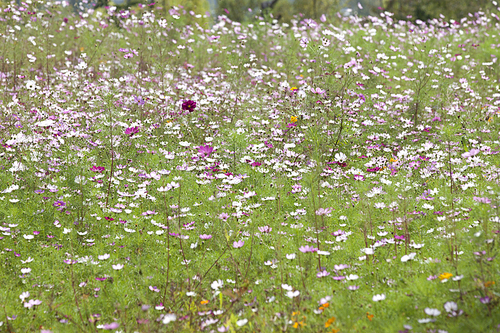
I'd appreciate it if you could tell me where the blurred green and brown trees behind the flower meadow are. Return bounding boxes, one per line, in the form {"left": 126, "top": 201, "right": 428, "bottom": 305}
{"left": 80, "top": 0, "right": 496, "bottom": 24}
